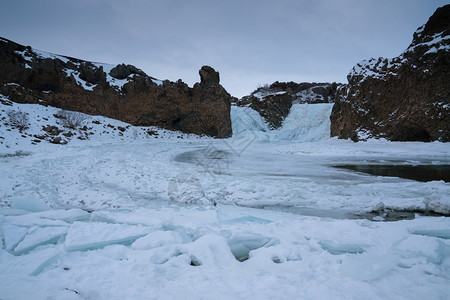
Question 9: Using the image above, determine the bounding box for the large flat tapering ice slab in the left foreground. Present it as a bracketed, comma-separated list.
[65, 222, 150, 251]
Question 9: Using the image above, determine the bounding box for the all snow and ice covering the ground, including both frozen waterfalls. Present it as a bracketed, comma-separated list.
[0, 99, 450, 299]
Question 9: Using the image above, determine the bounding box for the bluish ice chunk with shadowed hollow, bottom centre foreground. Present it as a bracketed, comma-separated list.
[228, 234, 278, 261]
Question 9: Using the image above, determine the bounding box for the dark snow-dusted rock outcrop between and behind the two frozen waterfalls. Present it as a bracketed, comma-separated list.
[234, 81, 340, 129]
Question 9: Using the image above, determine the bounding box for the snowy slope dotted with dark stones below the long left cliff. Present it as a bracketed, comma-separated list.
[0, 95, 200, 154]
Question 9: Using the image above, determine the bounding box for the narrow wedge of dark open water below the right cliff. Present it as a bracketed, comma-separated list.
[334, 164, 450, 182]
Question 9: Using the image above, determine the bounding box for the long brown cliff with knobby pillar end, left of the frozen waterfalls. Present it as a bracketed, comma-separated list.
[0, 38, 232, 138]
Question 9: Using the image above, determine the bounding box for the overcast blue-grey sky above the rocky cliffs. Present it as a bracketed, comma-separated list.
[0, 0, 450, 97]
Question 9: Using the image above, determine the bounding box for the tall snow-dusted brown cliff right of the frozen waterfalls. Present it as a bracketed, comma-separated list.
[331, 5, 450, 142]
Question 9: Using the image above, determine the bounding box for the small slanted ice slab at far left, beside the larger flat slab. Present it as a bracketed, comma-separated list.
[14, 227, 68, 255]
